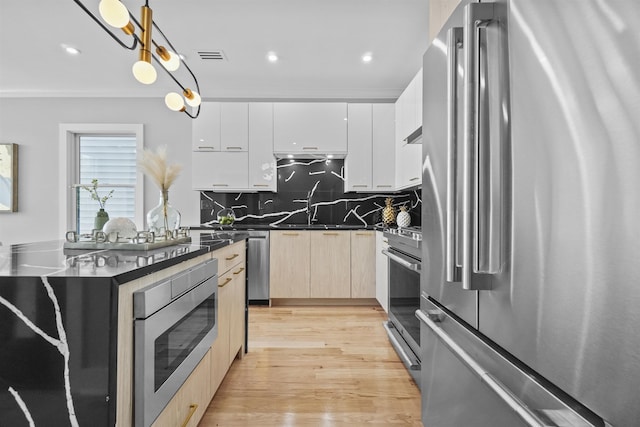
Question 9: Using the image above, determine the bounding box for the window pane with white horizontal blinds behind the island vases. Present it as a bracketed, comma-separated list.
[74, 134, 137, 233]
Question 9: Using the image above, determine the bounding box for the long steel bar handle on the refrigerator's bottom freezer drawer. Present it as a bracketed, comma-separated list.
[416, 310, 549, 427]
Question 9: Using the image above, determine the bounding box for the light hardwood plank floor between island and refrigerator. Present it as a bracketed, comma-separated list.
[200, 306, 422, 427]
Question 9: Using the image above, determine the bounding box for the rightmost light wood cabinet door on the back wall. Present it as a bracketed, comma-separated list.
[351, 230, 376, 298]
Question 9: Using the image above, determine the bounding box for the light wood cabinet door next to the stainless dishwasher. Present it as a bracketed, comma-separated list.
[269, 230, 311, 298]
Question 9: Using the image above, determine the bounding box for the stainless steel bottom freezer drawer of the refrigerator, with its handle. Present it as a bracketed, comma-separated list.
[416, 295, 603, 427]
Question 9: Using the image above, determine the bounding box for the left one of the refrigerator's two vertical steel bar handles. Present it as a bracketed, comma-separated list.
[446, 27, 462, 282]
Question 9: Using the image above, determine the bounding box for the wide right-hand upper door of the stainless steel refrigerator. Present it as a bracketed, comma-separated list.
[470, 0, 640, 426]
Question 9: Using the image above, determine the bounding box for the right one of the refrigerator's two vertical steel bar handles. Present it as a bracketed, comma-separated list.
[462, 3, 495, 290]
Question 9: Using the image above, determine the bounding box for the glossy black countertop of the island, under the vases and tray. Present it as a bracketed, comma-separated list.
[0, 236, 248, 284]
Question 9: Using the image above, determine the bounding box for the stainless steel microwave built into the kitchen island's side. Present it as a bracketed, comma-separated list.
[133, 259, 218, 427]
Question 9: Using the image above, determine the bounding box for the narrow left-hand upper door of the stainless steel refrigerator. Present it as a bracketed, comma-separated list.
[421, 0, 477, 326]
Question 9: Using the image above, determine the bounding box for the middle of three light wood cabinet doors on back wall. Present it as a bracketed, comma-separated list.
[309, 231, 351, 298]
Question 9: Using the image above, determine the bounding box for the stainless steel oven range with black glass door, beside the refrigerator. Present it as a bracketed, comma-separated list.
[383, 227, 422, 387]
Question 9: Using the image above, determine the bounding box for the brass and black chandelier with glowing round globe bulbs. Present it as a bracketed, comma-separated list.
[73, 0, 201, 119]
